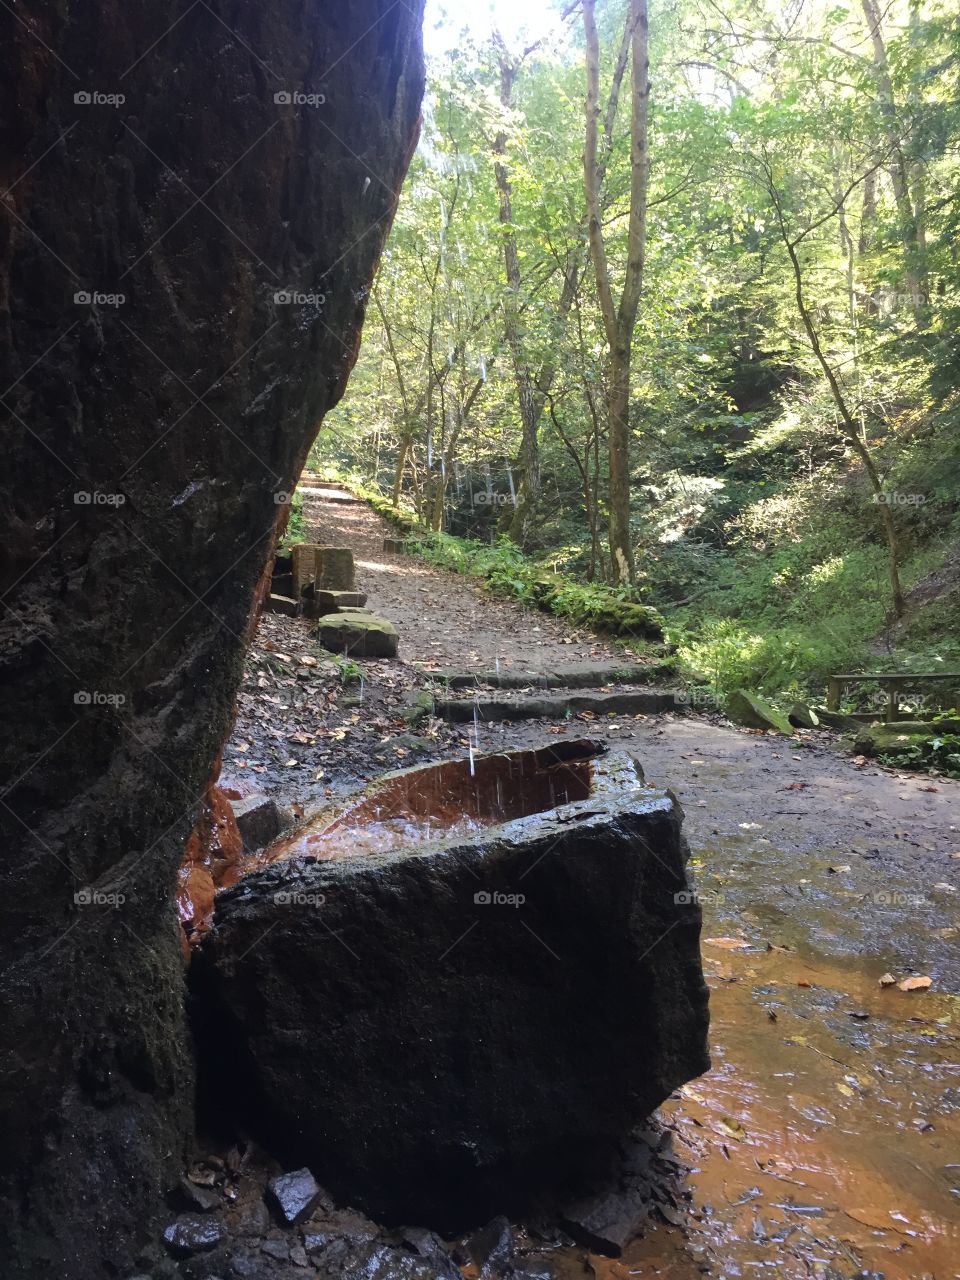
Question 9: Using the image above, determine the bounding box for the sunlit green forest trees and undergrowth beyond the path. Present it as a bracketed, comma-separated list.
[321, 0, 960, 690]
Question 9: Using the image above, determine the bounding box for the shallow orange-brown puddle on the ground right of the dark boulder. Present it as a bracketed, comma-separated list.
[545, 945, 960, 1280]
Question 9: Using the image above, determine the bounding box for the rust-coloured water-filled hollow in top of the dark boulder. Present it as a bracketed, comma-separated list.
[262, 741, 598, 863]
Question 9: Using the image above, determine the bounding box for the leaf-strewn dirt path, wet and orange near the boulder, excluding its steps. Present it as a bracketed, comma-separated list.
[225, 483, 960, 1280]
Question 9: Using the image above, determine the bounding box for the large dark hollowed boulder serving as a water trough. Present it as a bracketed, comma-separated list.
[195, 744, 709, 1229]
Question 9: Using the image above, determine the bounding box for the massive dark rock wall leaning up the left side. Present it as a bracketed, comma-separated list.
[0, 0, 422, 1280]
